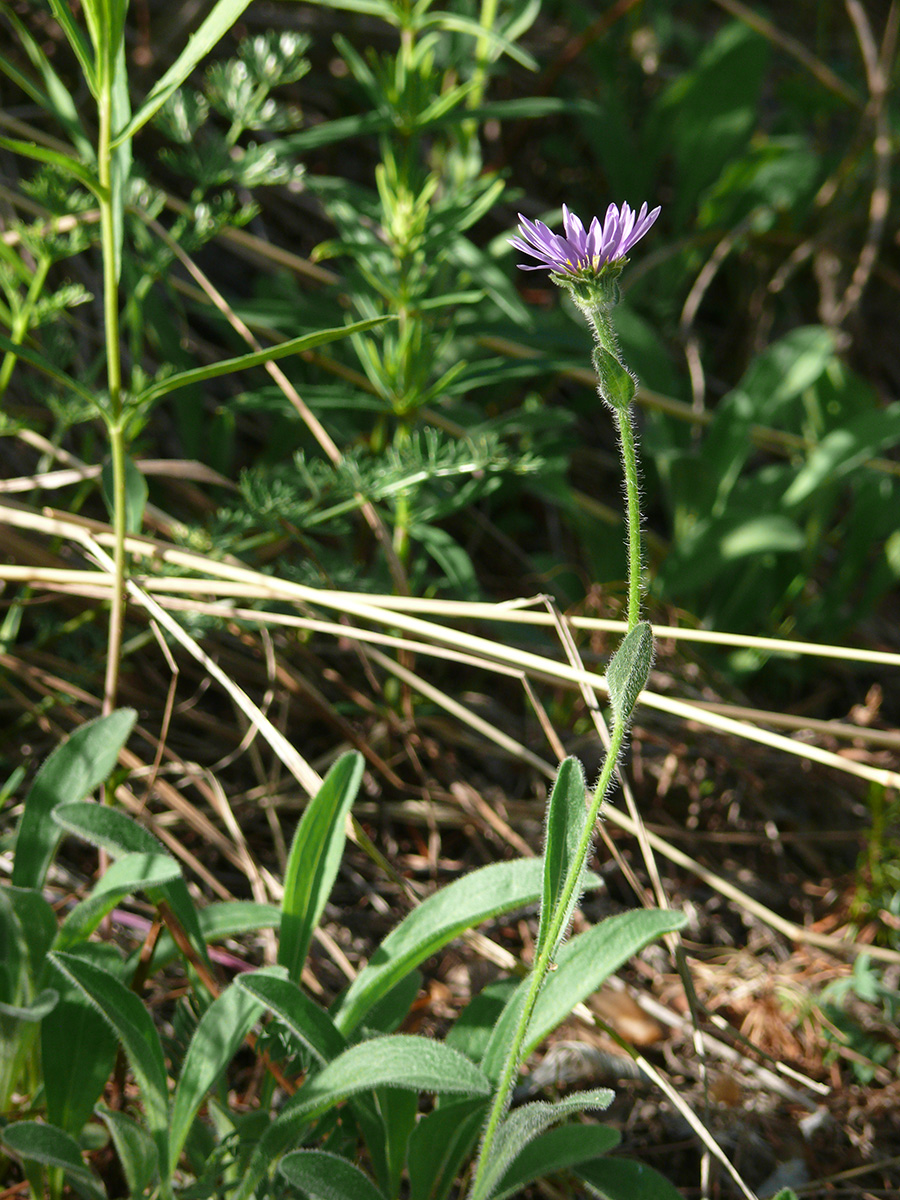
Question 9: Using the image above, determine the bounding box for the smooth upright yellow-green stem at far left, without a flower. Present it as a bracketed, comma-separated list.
[97, 71, 126, 715]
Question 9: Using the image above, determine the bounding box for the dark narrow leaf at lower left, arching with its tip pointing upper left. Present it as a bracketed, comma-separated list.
[47, 950, 169, 1182]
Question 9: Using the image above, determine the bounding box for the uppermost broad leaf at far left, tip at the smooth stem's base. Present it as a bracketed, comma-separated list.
[12, 708, 137, 888]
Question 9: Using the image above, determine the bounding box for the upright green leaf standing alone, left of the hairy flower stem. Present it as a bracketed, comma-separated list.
[278, 750, 364, 982]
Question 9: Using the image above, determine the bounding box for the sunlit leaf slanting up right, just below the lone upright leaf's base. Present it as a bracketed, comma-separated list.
[168, 967, 282, 1177]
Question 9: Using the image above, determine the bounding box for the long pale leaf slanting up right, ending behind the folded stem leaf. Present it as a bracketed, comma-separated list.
[335, 858, 542, 1034]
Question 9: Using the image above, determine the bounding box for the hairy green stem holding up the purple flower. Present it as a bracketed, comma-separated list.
[472, 277, 642, 1196]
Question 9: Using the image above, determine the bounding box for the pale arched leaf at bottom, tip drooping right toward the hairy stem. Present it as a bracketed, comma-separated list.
[234, 1033, 491, 1200]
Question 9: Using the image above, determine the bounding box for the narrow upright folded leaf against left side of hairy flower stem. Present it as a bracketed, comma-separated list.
[534, 758, 587, 959]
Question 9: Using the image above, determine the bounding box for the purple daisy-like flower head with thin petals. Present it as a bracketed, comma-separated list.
[510, 204, 660, 275]
